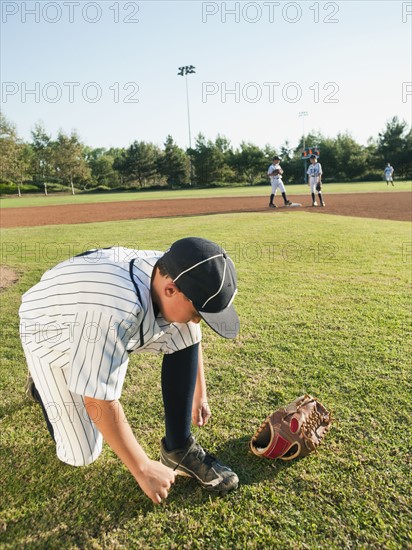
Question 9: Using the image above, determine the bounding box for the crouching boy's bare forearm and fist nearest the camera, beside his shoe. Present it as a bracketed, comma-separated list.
[84, 397, 175, 504]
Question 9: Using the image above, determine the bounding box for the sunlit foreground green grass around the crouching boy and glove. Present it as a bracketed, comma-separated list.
[0, 209, 412, 549]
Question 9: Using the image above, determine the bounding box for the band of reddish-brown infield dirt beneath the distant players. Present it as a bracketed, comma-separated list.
[0, 192, 412, 228]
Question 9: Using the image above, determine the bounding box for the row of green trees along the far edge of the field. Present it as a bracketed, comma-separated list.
[0, 114, 412, 195]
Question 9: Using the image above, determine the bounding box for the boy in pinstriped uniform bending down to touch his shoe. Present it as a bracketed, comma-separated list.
[19, 237, 239, 503]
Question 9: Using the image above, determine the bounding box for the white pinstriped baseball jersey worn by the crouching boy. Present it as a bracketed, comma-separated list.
[19, 247, 201, 400]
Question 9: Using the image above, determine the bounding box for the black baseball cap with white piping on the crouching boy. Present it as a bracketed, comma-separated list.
[162, 237, 240, 338]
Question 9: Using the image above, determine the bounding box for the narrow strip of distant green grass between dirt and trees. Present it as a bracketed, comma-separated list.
[0, 181, 412, 208]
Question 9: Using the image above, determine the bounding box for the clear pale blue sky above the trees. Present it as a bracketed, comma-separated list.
[1, 0, 412, 148]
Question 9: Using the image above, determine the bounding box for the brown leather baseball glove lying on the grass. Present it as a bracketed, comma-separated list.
[250, 394, 332, 460]
